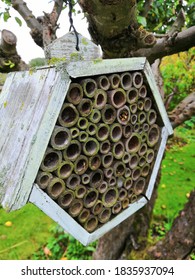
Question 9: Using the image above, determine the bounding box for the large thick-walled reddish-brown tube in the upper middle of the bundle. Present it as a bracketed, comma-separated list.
[108, 88, 127, 109]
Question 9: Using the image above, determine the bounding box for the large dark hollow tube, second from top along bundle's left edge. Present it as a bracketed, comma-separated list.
[58, 103, 79, 127]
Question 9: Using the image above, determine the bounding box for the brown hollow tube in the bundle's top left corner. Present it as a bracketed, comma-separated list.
[66, 83, 83, 105]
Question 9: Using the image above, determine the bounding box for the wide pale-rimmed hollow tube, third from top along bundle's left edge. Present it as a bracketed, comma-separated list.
[50, 126, 72, 150]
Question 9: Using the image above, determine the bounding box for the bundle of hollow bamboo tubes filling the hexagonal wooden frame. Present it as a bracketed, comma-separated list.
[36, 71, 161, 232]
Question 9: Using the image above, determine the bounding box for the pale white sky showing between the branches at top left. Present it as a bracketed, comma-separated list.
[0, 0, 90, 63]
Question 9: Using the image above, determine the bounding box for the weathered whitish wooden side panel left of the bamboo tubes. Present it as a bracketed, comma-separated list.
[0, 68, 70, 210]
